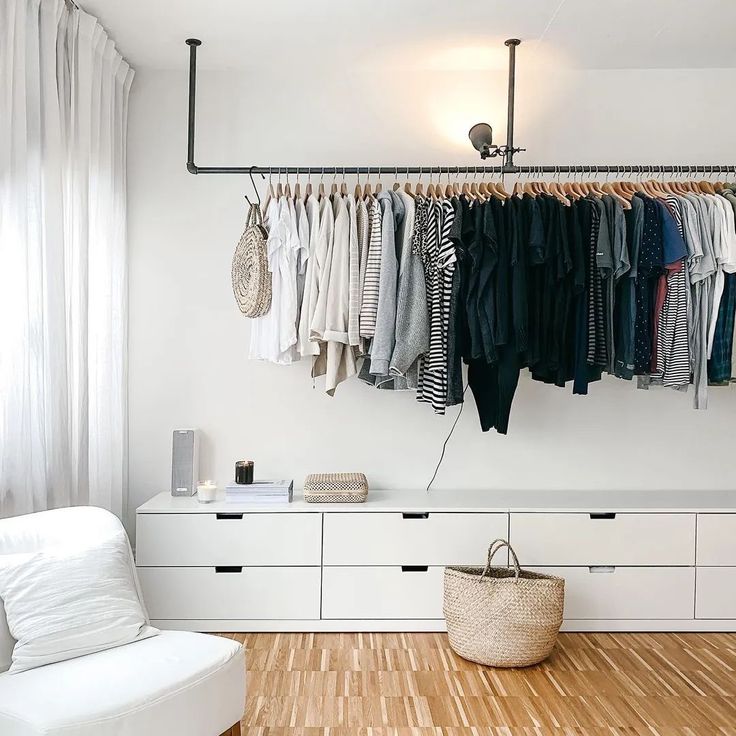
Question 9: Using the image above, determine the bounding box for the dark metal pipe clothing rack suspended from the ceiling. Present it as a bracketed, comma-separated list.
[186, 38, 736, 177]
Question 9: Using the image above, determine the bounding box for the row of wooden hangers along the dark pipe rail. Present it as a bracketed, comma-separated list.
[256, 170, 728, 209]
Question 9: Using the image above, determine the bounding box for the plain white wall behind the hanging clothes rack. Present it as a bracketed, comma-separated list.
[129, 62, 736, 524]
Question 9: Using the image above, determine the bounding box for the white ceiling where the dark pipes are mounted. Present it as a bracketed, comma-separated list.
[79, 0, 736, 71]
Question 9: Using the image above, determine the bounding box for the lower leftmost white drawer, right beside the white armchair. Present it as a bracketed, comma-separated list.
[138, 567, 320, 619]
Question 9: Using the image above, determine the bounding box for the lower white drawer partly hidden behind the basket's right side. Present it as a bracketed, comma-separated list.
[535, 567, 695, 619]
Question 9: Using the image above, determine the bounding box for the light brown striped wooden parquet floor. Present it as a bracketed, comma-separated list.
[216, 634, 736, 736]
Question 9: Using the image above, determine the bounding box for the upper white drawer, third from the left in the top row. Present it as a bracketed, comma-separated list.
[510, 513, 695, 566]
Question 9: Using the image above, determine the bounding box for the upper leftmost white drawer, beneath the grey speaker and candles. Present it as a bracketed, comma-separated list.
[136, 513, 322, 567]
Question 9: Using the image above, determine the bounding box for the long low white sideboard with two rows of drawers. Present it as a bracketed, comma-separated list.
[136, 491, 736, 631]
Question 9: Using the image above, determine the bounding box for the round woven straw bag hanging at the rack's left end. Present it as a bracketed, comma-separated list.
[232, 204, 271, 317]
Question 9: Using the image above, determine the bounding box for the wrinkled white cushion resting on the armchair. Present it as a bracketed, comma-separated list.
[0, 528, 158, 673]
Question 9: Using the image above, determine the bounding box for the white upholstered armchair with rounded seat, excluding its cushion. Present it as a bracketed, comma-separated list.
[0, 507, 245, 736]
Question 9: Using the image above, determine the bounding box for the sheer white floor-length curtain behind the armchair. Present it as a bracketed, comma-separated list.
[0, 0, 133, 516]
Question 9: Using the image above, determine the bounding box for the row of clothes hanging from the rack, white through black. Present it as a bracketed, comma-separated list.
[250, 175, 736, 434]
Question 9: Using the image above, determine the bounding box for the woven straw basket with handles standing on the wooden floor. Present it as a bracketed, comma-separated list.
[444, 539, 565, 667]
